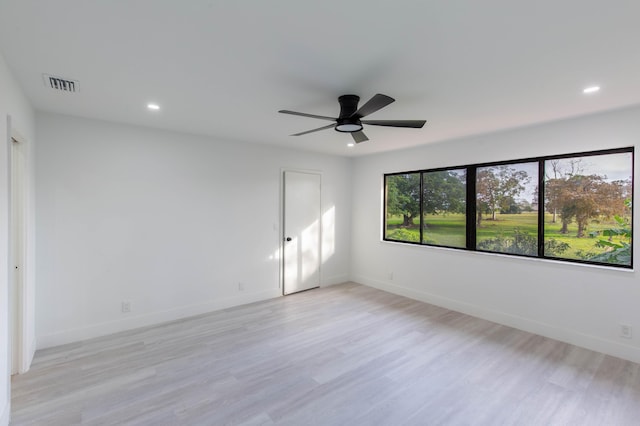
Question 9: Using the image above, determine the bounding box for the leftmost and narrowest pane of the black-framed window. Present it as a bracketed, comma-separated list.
[384, 173, 420, 243]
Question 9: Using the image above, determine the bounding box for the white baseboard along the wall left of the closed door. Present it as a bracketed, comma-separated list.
[37, 289, 282, 349]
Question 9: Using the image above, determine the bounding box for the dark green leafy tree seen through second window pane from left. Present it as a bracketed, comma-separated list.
[422, 170, 467, 214]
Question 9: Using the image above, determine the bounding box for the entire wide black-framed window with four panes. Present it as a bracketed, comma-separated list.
[384, 148, 633, 268]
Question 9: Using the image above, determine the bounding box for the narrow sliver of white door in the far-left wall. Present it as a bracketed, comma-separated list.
[9, 139, 25, 374]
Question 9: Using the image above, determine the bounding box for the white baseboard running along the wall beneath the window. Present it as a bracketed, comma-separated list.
[352, 276, 640, 363]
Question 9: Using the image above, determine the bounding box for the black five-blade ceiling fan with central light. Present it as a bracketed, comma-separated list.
[278, 93, 426, 143]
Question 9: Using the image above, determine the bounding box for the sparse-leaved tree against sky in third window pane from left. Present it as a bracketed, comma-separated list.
[476, 166, 531, 226]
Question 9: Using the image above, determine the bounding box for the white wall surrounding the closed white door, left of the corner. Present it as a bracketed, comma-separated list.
[36, 113, 351, 348]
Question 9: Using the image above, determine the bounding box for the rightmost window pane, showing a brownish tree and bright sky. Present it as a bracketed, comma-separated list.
[544, 152, 633, 266]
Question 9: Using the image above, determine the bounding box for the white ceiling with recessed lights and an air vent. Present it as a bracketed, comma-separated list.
[0, 0, 640, 156]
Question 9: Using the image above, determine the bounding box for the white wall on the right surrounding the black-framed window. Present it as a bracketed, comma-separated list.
[351, 107, 640, 362]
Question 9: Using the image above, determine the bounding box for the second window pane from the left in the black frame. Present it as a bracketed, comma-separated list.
[422, 169, 467, 247]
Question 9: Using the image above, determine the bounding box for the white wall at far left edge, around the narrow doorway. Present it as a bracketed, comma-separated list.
[0, 51, 35, 424]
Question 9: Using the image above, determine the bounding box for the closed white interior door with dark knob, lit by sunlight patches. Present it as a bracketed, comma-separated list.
[282, 171, 322, 294]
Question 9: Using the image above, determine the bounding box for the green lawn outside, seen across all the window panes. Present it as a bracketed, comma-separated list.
[386, 212, 632, 260]
